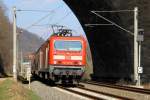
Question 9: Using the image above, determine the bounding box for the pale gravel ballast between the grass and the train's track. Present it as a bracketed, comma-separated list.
[26, 81, 89, 100]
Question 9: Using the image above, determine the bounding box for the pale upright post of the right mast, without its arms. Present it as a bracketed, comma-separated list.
[134, 7, 139, 85]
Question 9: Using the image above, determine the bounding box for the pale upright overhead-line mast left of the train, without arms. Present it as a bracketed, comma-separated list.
[13, 7, 17, 81]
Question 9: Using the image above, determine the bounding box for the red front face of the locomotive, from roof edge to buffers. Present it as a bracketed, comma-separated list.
[49, 36, 86, 82]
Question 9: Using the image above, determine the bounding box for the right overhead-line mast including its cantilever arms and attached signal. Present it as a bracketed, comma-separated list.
[90, 7, 144, 86]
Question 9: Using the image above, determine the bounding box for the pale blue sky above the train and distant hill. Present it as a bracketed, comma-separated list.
[3, 0, 85, 39]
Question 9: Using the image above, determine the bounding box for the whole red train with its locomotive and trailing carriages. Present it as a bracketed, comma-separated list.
[31, 29, 87, 84]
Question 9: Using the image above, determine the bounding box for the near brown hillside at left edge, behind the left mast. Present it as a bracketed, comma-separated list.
[0, 1, 13, 74]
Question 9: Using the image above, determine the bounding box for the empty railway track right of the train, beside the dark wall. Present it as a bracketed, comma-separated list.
[83, 81, 150, 95]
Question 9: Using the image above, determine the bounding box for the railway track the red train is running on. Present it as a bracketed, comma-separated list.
[58, 86, 131, 100]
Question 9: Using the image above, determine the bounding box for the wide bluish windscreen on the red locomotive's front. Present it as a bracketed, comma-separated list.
[54, 40, 82, 51]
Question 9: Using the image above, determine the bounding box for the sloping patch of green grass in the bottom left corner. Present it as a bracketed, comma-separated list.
[0, 79, 40, 100]
